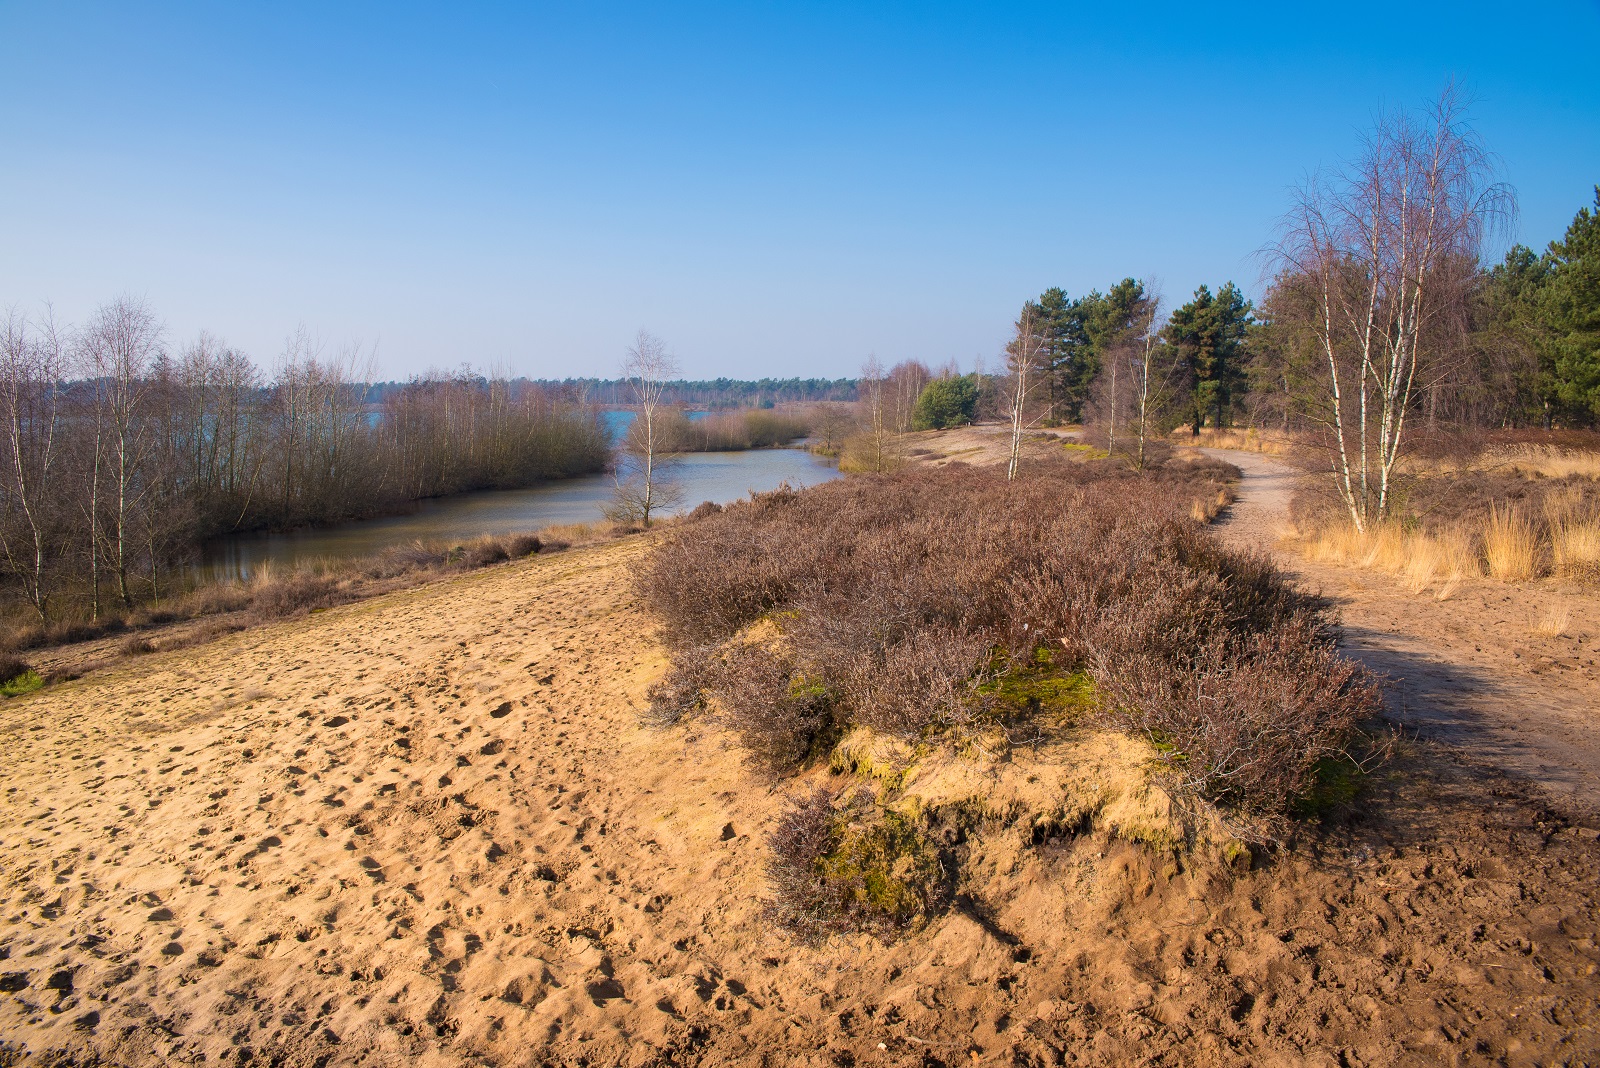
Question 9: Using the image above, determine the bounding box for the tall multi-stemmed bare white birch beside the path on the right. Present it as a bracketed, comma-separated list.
[1274, 86, 1515, 531]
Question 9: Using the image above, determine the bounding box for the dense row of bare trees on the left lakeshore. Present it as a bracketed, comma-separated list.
[0, 299, 611, 622]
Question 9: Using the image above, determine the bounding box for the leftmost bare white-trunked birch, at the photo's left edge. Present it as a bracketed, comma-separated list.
[0, 309, 67, 624]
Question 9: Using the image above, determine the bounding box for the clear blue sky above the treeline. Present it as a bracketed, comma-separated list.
[0, 0, 1600, 377]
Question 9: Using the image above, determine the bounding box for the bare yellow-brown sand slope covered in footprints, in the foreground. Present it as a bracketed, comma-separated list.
[0, 539, 1600, 1066]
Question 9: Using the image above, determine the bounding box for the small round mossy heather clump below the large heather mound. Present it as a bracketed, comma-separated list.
[766, 788, 947, 942]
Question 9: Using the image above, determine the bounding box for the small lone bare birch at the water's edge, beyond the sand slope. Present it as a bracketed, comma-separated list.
[605, 329, 683, 526]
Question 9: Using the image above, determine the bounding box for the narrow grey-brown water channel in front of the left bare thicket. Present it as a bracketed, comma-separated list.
[198, 449, 838, 580]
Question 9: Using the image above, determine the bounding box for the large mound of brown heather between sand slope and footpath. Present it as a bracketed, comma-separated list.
[637, 460, 1376, 819]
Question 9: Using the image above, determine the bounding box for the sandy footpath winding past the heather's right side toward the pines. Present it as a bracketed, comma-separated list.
[1205, 449, 1600, 812]
